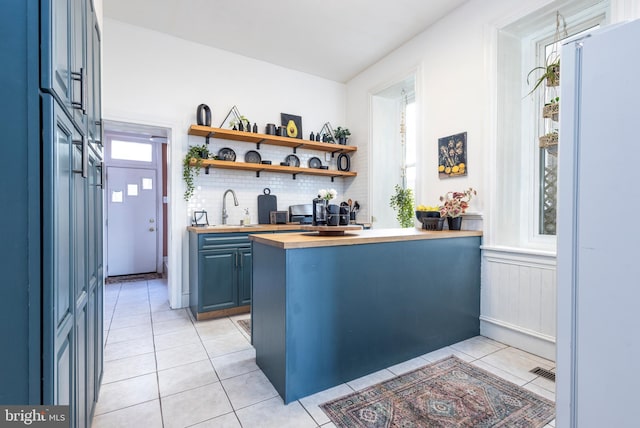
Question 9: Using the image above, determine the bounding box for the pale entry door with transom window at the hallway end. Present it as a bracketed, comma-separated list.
[104, 121, 170, 277]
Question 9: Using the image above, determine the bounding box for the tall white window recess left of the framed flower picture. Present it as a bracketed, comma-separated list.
[369, 73, 417, 228]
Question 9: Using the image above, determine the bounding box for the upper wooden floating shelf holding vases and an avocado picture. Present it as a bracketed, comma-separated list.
[189, 125, 358, 155]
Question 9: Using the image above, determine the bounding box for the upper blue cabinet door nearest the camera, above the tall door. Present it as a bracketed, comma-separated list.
[41, 0, 89, 130]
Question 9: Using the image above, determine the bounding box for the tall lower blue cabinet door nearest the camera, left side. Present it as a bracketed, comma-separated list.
[42, 95, 77, 404]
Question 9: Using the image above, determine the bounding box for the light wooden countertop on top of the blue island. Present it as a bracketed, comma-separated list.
[249, 228, 482, 249]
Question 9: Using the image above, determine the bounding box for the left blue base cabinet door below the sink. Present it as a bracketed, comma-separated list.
[198, 249, 238, 312]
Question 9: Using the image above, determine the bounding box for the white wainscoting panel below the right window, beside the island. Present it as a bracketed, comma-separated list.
[480, 247, 556, 361]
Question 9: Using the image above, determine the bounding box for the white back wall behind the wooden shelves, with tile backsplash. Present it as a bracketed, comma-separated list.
[103, 19, 348, 307]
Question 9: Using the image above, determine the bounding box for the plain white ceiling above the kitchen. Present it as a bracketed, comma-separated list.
[103, 0, 467, 82]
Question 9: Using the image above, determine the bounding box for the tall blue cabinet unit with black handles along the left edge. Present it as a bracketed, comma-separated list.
[0, 0, 104, 427]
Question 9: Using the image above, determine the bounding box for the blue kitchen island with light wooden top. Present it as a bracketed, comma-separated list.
[250, 229, 481, 403]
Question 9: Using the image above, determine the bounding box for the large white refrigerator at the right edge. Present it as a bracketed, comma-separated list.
[556, 21, 640, 428]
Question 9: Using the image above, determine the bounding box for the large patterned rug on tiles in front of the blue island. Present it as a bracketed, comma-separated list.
[320, 356, 555, 428]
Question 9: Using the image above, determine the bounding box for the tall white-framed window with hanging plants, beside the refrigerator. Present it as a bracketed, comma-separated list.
[489, 0, 609, 247]
